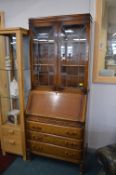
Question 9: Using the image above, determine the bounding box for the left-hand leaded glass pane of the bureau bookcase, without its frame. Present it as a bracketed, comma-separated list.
[33, 27, 55, 86]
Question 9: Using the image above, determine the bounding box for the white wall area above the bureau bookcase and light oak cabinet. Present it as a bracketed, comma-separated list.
[0, 0, 89, 28]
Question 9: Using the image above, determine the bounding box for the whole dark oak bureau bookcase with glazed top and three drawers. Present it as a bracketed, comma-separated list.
[26, 14, 90, 173]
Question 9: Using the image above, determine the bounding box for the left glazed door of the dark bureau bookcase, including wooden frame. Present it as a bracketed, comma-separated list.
[30, 23, 57, 89]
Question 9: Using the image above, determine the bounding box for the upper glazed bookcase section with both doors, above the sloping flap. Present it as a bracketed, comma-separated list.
[29, 15, 90, 91]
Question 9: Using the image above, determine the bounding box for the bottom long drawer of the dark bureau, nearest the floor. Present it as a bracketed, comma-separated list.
[28, 141, 82, 163]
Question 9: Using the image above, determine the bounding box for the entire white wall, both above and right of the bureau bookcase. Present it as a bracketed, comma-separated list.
[0, 0, 116, 148]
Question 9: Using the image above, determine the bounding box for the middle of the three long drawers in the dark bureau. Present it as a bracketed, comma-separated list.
[27, 131, 83, 149]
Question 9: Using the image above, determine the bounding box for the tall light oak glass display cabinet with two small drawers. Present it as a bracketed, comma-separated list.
[0, 28, 30, 159]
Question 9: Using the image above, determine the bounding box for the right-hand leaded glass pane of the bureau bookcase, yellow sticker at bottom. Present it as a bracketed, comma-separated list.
[59, 25, 88, 87]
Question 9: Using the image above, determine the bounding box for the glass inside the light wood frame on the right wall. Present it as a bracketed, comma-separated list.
[99, 0, 116, 76]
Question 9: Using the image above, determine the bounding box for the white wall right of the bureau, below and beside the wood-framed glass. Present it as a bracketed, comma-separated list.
[88, 0, 116, 148]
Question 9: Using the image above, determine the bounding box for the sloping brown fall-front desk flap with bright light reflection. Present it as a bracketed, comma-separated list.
[26, 91, 86, 122]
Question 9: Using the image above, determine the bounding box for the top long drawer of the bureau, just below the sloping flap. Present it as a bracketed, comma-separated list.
[27, 121, 84, 139]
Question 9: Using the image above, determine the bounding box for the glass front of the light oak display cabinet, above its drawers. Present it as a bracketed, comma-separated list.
[0, 34, 20, 124]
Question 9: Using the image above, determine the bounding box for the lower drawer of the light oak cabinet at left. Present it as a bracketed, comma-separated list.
[3, 137, 22, 155]
